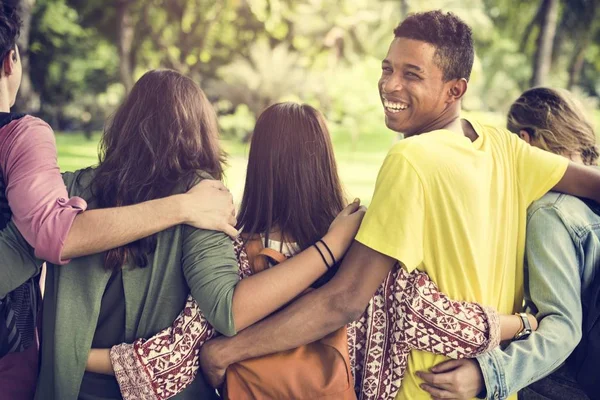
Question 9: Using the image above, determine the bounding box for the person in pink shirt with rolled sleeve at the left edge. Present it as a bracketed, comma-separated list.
[0, 2, 237, 400]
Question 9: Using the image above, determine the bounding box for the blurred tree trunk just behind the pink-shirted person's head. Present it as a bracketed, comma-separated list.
[15, 0, 40, 113]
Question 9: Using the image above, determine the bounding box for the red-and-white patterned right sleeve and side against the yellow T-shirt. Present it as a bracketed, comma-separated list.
[348, 266, 500, 400]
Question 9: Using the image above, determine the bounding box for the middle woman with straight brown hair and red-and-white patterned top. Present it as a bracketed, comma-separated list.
[88, 103, 535, 399]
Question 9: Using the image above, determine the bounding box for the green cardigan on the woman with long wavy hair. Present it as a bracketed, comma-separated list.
[36, 169, 239, 400]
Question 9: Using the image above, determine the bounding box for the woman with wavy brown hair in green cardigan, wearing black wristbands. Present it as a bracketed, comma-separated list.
[36, 70, 363, 399]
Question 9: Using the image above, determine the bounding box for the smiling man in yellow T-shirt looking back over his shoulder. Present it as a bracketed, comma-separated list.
[201, 11, 600, 400]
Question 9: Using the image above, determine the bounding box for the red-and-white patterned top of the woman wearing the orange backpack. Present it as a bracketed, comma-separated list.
[110, 239, 500, 400]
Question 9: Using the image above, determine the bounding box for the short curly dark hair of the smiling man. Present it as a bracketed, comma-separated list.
[394, 10, 474, 82]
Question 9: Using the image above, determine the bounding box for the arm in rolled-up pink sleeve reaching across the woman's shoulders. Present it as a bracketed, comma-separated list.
[0, 117, 236, 264]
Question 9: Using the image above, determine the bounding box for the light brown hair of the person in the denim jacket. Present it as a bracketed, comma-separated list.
[507, 87, 598, 165]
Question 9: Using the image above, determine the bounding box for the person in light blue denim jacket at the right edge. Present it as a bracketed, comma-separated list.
[424, 87, 600, 400]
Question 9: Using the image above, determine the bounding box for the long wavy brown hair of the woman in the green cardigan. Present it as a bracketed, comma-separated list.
[92, 70, 224, 269]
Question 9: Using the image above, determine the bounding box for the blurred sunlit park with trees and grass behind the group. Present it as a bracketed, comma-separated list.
[15, 0, 600, 203]
